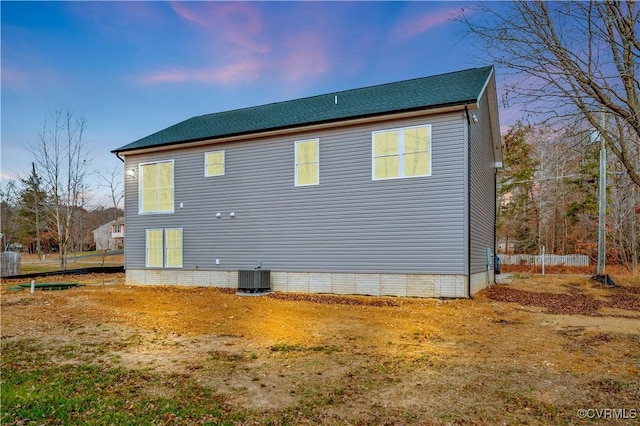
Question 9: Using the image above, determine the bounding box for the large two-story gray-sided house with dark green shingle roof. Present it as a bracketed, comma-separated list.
[112, 67, 502, 297]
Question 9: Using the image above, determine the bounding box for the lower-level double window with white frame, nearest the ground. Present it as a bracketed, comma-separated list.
[145, 228, 182, 268]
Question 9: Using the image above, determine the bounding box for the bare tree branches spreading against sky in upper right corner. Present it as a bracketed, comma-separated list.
[461, 0, 640, 186]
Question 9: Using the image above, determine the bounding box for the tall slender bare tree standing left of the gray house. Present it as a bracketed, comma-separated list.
[29, 110, 90, 270]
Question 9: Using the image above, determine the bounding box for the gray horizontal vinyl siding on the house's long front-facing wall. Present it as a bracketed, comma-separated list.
[125, 113, 466, 274]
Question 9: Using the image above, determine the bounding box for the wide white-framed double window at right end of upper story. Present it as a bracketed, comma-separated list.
[371, 124, 431, 180]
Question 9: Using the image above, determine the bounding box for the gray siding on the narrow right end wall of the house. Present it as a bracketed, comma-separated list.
[469, 92, 496, 274]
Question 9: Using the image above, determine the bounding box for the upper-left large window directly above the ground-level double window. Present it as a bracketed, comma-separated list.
[138, 160, 174, 213]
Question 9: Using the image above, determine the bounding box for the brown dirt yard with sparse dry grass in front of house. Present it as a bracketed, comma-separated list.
[1, 274, 640, 425]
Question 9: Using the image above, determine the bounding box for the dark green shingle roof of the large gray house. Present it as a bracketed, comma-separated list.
[112, 67, 493, 153]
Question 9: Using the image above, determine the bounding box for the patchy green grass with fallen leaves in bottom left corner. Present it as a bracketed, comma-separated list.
[0, 341, 246, 425]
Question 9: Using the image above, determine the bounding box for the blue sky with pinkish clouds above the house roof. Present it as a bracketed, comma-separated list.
[0, 1, 504, 206]
